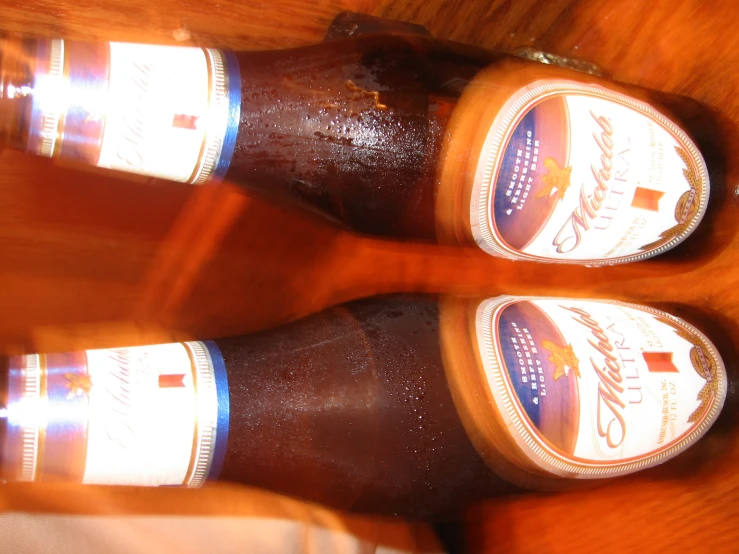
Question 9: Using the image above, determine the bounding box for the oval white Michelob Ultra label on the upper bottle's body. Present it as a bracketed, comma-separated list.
[470, 80, 709, 264]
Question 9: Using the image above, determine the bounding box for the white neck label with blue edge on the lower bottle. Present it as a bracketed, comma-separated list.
[3, 342, 228, 487]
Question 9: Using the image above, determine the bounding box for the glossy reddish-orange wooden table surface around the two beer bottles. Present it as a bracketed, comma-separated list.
[0, 0, 739, 552]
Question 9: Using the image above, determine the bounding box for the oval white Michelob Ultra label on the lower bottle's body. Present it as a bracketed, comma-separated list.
[477, 298, 726, 478]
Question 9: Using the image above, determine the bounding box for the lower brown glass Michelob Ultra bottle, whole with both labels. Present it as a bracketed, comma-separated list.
[0, 296, 727, 518]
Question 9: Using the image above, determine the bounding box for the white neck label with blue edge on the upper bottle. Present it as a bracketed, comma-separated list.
[28, 39, 241, 184]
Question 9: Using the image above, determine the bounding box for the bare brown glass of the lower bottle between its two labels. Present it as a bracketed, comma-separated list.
[219, 297, 513, 517]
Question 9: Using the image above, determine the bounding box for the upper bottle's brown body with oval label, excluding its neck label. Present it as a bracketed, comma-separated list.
[229, 35, 709, 265]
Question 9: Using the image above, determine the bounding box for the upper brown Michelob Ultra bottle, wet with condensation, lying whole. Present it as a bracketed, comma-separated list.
[0, 14, 718, 265]
